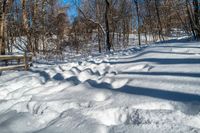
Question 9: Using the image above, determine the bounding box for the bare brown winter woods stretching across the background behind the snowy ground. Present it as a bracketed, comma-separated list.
[0, 0, 200, 58]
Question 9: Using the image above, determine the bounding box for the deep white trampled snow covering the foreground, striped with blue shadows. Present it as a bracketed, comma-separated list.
[0, 42, 200, 133]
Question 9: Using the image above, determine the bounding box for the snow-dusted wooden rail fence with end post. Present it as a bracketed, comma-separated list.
[0, 53, 32, 71]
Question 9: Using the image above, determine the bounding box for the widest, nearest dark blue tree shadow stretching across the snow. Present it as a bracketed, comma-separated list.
[87, 80, 200, 102]
